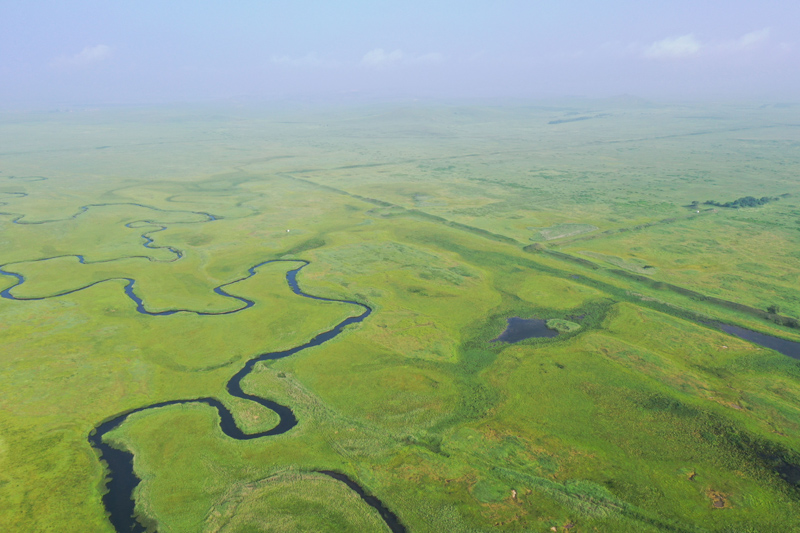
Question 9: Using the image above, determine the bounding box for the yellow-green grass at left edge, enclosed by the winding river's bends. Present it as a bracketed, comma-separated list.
[0, 263, 358, 529]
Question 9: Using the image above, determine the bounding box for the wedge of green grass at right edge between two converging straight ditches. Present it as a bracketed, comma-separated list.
[565, 212, 800, 317]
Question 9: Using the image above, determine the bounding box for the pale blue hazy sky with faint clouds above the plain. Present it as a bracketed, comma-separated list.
[0, 0, 800, 106]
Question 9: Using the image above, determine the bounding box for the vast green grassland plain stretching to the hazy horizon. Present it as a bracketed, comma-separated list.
[0, 101, 800, 533]
